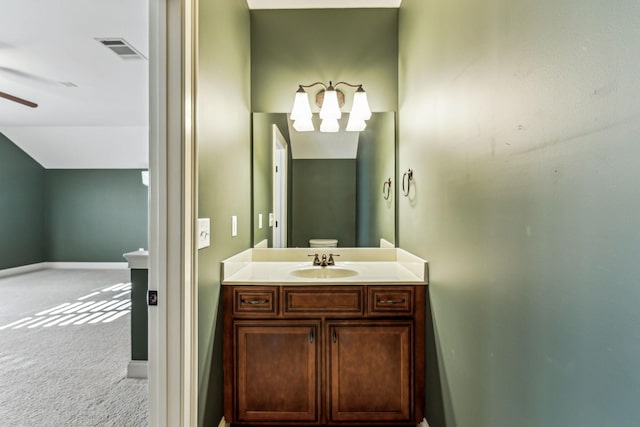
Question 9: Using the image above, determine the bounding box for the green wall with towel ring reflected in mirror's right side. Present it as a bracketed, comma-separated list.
[356, 113, 397, 247]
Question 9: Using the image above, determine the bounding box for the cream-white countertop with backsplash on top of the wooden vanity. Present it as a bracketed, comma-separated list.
[221, 248, 428, 285]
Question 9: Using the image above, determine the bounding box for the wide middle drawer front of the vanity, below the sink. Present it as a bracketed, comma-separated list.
[283, 286, 363, 315]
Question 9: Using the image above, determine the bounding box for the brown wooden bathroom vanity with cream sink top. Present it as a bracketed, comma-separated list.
[222, 248, 428, 426]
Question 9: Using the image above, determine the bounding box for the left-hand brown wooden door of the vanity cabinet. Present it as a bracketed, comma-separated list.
[235, 321, 320, 422]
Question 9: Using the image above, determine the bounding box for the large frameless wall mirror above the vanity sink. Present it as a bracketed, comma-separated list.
[253, 112, 397, 247]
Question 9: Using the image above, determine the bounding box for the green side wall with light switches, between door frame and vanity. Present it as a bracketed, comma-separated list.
[196, 0, 251, 426]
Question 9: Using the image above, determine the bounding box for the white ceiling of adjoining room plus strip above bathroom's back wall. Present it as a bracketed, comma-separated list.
[0, 0, 401, 169]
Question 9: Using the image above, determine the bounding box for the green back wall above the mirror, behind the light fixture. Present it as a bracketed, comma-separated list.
[251, 9, 398, 113]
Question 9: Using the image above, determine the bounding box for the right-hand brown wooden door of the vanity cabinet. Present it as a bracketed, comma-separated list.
[327, 321, 413, 422]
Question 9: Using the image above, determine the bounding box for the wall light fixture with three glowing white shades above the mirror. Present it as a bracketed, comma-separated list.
[291, 82, 371, 132]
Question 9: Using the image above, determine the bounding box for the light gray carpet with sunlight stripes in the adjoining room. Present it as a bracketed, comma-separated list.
[0, 270, 148, 427]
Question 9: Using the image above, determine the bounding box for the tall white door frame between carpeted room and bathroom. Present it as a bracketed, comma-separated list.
[148, 0, 198, 427]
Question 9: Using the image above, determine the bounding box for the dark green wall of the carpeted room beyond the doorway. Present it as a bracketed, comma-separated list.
[0, 134, 148, 269]
